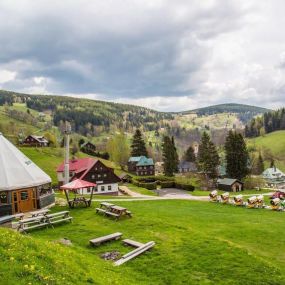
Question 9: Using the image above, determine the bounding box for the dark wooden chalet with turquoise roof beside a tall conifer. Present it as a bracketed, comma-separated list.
[128, 156, 155, 176]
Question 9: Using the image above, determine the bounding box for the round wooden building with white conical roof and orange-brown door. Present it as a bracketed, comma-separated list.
[0, 133, 55, 216]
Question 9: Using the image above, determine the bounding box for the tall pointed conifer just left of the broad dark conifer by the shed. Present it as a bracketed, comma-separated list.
[198, 132, 220, 178]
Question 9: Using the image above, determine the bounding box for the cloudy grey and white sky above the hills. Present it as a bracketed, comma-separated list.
[0, 0, 285, 111]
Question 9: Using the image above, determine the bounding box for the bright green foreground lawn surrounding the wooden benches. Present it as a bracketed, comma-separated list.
[0, 200, 285, 285]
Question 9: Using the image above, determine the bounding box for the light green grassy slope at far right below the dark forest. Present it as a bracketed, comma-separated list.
[248, 131, 285, 172]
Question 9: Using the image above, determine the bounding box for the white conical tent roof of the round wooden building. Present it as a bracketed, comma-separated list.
[0, 133, 51, 191]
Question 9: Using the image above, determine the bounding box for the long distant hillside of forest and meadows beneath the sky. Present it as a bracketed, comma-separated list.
[0, 91, 266, 159]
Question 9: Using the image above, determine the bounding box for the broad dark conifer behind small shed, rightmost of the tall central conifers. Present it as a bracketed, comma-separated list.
[225, 131, 249, 179]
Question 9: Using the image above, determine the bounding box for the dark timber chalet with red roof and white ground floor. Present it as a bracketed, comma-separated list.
[57, 157, 121, 195]
